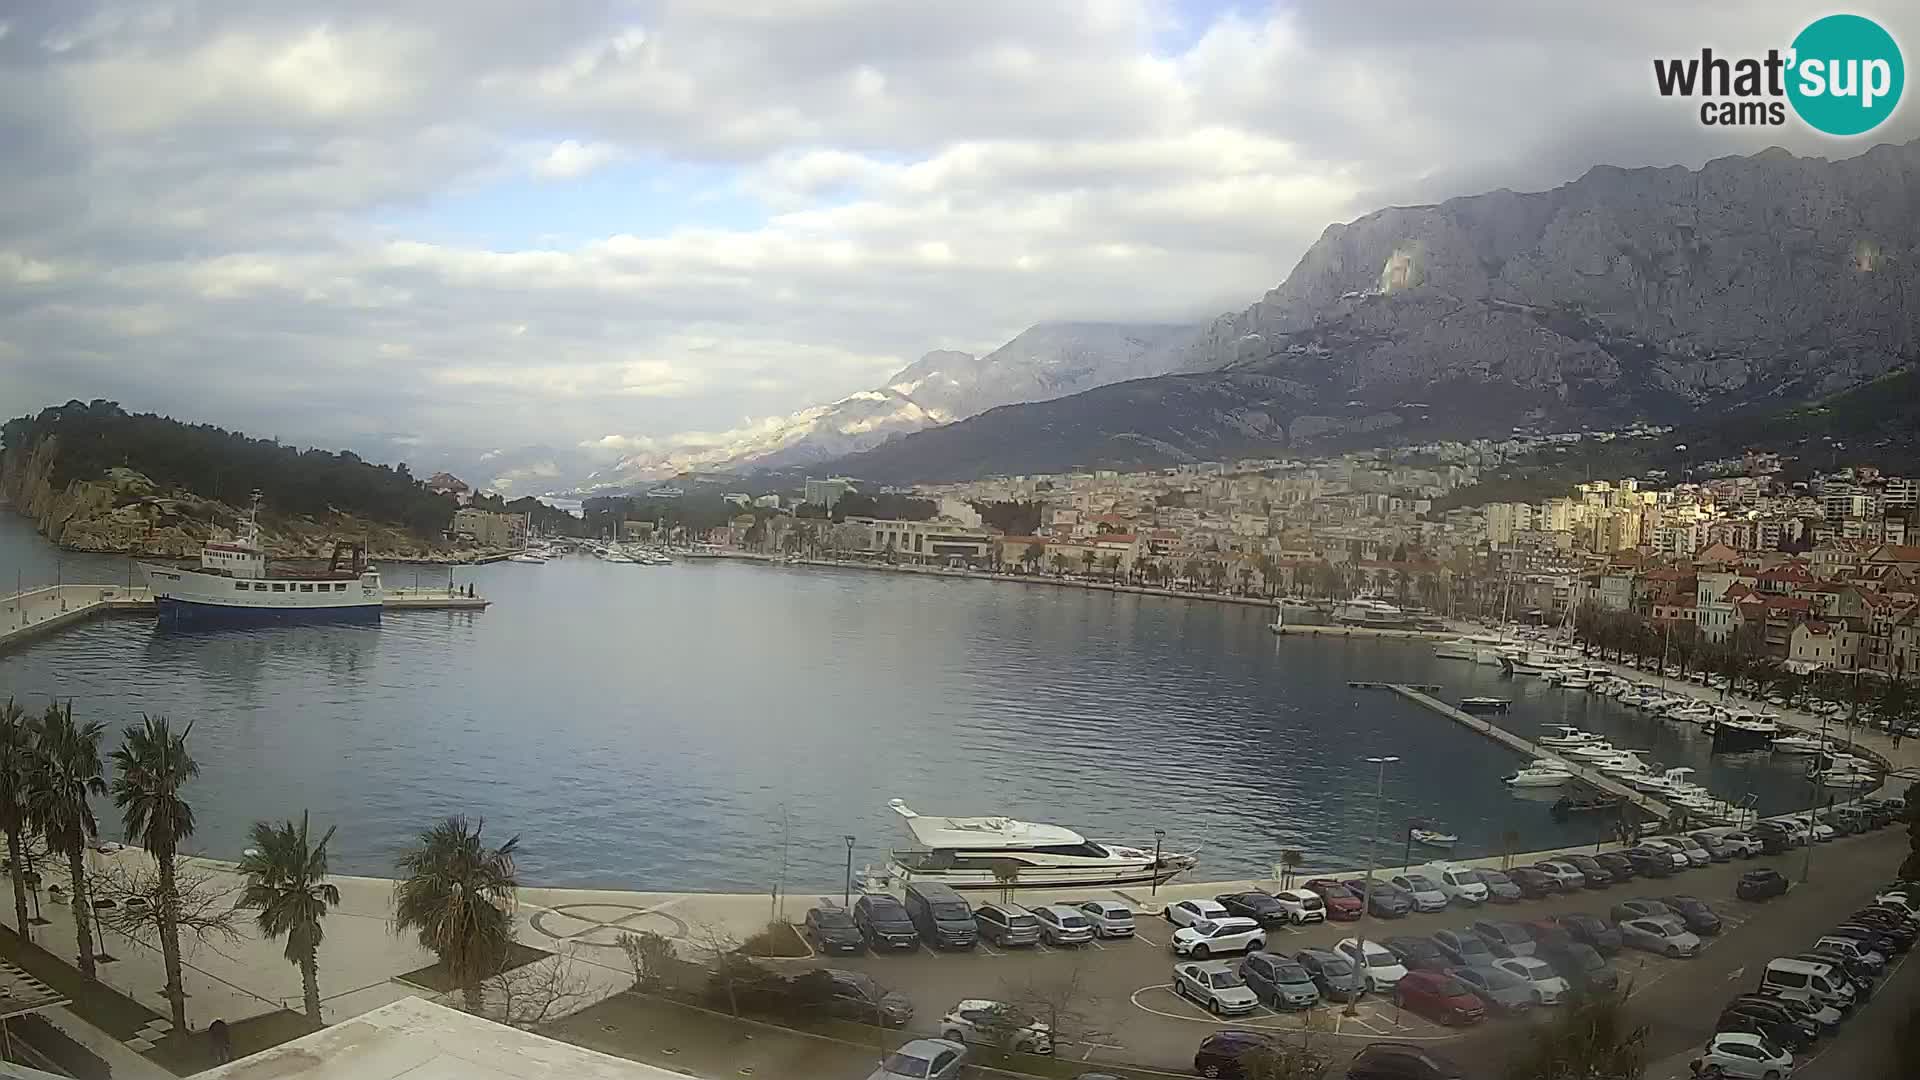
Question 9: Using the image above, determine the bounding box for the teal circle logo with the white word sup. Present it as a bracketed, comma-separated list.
[1788, 15, 1907, 135]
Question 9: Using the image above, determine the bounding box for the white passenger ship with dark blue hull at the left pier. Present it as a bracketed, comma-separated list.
[142, 496, 382, 626]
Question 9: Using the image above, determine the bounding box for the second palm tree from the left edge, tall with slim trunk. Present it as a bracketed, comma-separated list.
[27, 701, 108, 978]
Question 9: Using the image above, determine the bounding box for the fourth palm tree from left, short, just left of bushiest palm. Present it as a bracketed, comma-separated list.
[234, 811, 340, 1024]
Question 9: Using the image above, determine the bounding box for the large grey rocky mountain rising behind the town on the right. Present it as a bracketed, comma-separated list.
[835, 142, 1920, 482]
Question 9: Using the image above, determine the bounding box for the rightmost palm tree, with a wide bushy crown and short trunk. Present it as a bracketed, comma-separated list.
[394, 815, 520, 1015]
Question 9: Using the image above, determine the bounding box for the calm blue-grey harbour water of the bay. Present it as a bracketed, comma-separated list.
[0, 511, 1807, 892]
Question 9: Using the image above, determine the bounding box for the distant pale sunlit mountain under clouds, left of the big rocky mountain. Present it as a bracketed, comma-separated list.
[582, 323, 1198, 490]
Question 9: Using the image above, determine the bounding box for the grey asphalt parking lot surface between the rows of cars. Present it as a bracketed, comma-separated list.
[779, 828, 1907, 1072]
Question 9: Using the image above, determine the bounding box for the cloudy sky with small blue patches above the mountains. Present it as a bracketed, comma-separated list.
[0, 0, 1920, 490]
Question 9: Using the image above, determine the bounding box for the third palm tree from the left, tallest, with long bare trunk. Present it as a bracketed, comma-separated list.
[113, 717, 200, 1032]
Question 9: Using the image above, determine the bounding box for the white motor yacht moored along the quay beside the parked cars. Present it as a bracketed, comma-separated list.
[887, 799, 1198, 888]
